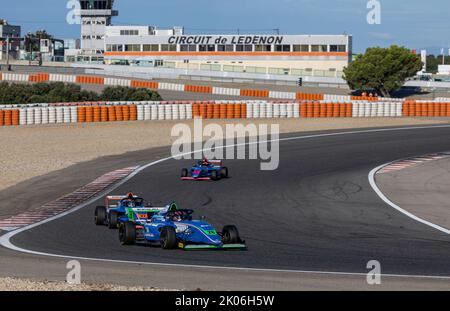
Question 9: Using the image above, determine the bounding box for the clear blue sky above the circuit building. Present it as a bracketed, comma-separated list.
[0, 0, 450, 53]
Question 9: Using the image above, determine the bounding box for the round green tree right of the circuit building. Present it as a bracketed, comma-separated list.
[344, 45, 423, 97]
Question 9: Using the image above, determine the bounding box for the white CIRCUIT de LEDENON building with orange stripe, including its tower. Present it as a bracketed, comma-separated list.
[76, 1, 352, 77]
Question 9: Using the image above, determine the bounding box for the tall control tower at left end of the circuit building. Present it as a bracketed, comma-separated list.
[79, 0, 119, 56]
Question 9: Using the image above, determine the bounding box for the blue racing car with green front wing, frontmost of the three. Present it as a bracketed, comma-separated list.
[119, 203, 247, 250]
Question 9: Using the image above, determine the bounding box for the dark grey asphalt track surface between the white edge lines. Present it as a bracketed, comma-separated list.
[7, 127, 450, 277]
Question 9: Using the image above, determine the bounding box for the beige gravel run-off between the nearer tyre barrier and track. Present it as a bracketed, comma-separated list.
[0, 118, 450, 190]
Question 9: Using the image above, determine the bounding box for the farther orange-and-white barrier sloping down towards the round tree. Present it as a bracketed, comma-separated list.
[0, 73, 386, 102]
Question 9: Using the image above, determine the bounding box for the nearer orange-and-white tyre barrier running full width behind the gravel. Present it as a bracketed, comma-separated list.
[0, 100, 444, 126]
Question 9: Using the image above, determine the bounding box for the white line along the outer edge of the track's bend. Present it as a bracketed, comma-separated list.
[0, 125, 450, 280]
